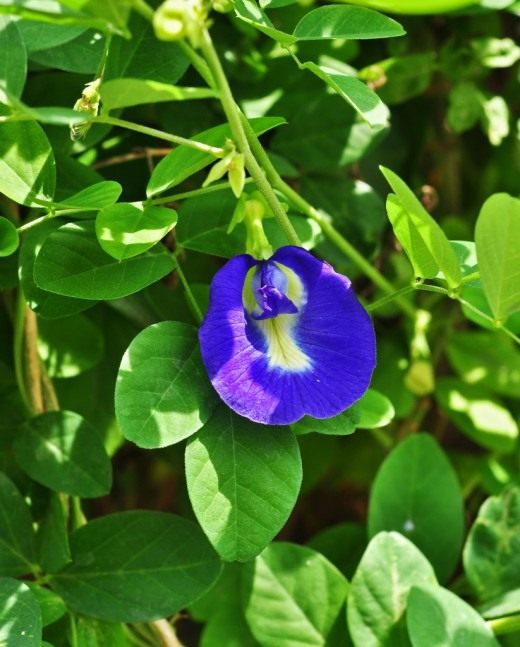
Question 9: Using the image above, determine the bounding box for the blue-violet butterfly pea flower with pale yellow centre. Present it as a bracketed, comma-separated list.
[199, 247, 376, 425]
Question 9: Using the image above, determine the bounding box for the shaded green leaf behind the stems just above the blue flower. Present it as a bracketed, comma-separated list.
[175, 191, 320, 258]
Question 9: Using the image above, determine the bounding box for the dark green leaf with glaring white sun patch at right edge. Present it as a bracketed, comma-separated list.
[435, 378, 518, 452]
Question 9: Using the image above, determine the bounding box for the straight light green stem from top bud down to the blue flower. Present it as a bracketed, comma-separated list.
[201, 30, 301, 247]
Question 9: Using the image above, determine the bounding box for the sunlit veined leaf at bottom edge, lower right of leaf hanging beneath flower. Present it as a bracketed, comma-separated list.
[243, 543, 348, 647]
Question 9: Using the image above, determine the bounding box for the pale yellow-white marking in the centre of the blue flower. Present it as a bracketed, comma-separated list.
[255, 314, 311, 372]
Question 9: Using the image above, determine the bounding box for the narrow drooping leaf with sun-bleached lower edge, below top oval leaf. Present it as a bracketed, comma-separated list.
[301, 62, 390, 128]
